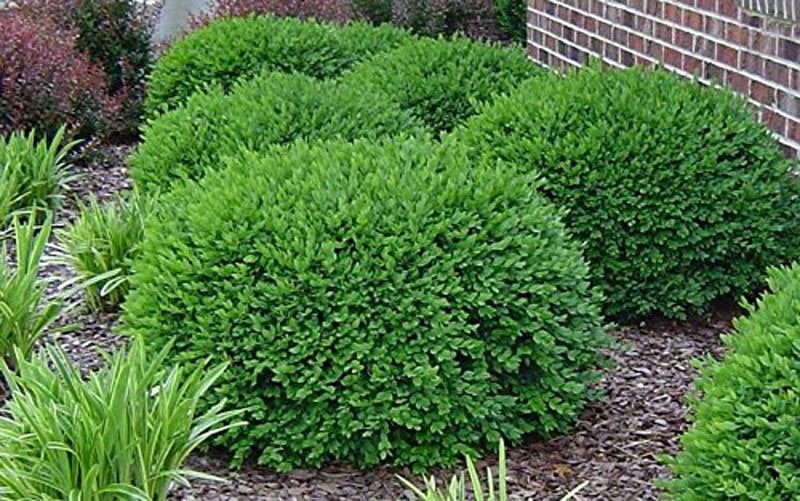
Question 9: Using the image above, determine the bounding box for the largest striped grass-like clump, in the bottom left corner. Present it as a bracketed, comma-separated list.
[0, 334, 247, 501]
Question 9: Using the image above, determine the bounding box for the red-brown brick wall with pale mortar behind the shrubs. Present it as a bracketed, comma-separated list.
[528, 0, 800, 157]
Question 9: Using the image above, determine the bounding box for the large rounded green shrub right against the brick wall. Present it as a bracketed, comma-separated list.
[454, 68, 800, 318]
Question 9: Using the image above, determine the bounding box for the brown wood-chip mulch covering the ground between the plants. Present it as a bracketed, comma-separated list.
[17, 142, 735, 500]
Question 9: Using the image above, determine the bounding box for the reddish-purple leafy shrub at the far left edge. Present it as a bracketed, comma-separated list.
[0, 9, 119, 135]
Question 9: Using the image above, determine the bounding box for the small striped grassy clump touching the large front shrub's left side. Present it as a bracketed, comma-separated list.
[58, 192, 155, 311]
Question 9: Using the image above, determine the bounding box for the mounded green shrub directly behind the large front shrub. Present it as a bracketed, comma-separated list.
[129, 73, 423, 191]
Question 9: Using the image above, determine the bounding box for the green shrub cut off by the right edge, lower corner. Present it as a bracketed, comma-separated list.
[668, 264, 800, 500]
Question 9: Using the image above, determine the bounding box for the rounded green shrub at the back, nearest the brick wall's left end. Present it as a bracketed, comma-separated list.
[343, 37, 542, 132]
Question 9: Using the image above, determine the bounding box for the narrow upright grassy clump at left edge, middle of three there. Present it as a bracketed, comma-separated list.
[0, 214, 62, 368]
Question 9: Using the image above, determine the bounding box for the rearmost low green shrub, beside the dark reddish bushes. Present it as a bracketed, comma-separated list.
[146, 17, 412, 116]
